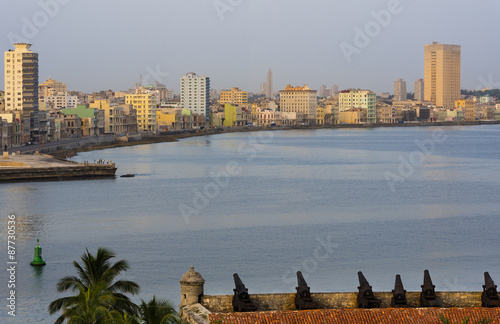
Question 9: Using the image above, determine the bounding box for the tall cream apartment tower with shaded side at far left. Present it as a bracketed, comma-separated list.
[4, 43, 38, 138]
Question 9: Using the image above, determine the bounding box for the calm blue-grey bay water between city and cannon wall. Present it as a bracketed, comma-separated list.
[0, 125, 500, 323]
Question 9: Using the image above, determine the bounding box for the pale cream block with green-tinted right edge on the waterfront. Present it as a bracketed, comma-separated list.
[339, 89, 377, 124]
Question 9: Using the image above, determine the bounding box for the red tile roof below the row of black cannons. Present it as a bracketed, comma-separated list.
[209, 307, 500, 324]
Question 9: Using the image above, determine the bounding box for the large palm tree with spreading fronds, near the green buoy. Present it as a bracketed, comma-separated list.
[48, 247, 139, 324]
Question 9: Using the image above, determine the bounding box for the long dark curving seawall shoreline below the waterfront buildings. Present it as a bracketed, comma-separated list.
[49, 120, 500, 159]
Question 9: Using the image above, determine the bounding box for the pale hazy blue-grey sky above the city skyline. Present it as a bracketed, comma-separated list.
[0, 0, 500, 93]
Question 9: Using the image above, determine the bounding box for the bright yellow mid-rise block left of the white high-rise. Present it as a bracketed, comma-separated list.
[125, 91, 157, 132]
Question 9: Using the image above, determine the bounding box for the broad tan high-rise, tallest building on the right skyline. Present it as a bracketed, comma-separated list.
[424, 42, 461, 108]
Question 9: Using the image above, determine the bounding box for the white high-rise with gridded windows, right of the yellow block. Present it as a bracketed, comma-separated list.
[180, 72, 210, 120]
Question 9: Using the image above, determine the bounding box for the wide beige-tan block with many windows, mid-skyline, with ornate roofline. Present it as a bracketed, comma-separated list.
[280, 85, 318, 124]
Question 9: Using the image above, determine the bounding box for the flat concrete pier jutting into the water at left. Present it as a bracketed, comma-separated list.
[0, 153, 116, 182]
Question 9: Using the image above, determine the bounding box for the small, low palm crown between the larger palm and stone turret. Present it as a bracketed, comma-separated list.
[139, 296, 179, 324]
